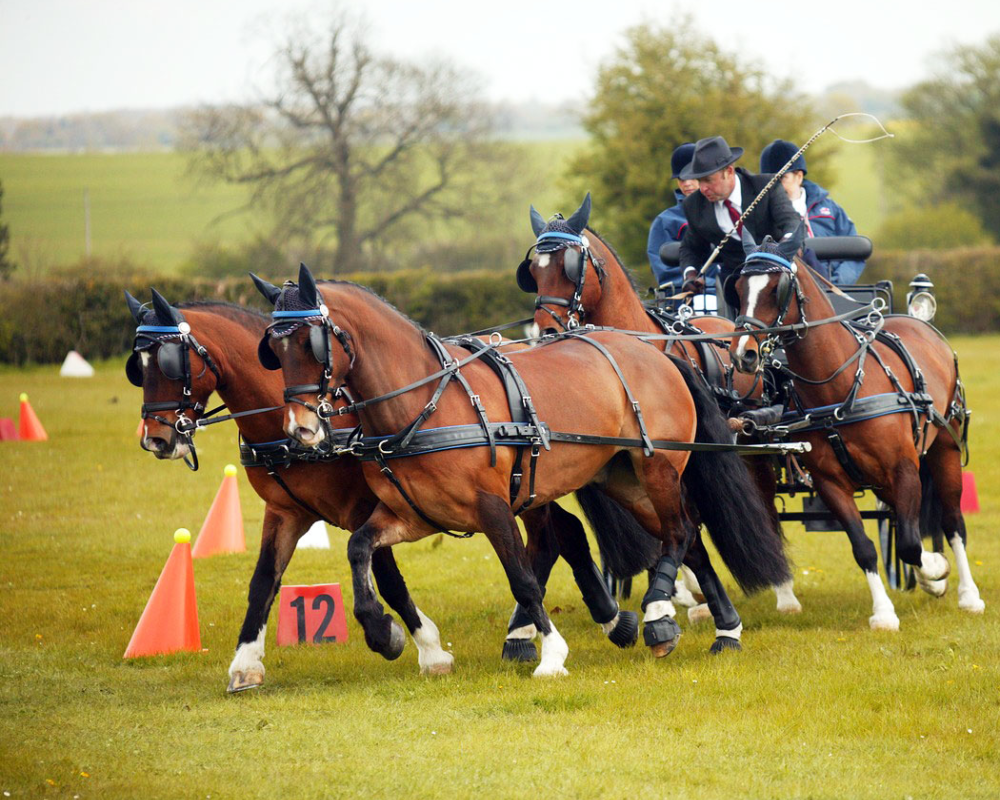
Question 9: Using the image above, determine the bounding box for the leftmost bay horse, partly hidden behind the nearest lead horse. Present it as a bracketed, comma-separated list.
[126, 289, 638, 692]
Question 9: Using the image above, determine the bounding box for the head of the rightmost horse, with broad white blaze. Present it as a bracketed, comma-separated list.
[725, 225, 805, 372]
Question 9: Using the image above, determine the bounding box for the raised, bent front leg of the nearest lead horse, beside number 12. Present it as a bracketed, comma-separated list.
[347, 504, 406, 661]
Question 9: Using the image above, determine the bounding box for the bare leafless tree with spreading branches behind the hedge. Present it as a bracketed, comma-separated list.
[184, 10, 516, 272]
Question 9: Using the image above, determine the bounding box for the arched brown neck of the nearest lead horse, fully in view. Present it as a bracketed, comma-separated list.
[319, 284, 441, 434]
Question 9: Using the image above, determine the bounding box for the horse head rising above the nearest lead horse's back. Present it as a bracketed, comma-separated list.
[517, 192, 604, 331]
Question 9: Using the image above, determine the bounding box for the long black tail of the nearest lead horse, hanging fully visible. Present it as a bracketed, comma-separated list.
[669, 356, 791, 594]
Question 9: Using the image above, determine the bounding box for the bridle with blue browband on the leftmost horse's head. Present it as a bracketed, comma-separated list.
[125, 321, 225, 471]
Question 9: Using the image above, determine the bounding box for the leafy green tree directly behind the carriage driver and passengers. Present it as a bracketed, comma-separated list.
[567, 19, 830, 273]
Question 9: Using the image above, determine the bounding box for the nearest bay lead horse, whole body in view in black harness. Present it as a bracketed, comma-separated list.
[252, 265, 788, 676]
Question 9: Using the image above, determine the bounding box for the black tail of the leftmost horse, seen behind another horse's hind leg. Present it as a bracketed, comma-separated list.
[576, 486, 663, 580]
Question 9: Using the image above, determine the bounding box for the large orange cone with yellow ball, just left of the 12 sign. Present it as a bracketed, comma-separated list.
[124, 528, 201, 658]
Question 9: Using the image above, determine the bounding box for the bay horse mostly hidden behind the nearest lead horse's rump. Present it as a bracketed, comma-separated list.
[517, 193, 802, 621]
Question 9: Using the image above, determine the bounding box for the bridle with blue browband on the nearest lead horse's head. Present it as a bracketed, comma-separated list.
[257, 303, 356, 424]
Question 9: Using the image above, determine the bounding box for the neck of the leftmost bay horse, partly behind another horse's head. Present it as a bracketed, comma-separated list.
[184, 310, 285, 442]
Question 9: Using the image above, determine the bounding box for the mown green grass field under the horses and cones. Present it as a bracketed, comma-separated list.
[0, 336, 1000, 800]
